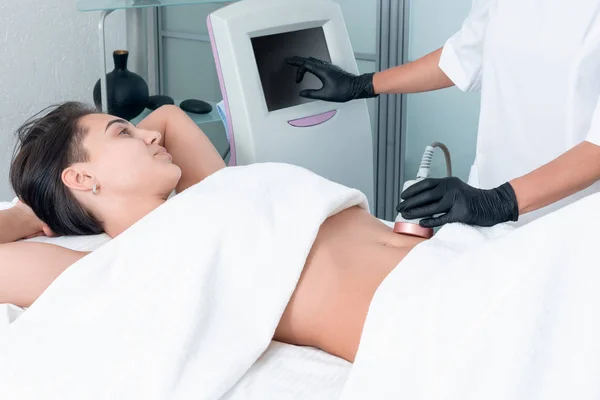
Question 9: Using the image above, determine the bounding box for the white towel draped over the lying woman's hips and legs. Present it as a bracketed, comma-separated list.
[342, 194, 600, 400]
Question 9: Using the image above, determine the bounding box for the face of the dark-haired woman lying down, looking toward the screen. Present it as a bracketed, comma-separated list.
[74, 114, 181, 197]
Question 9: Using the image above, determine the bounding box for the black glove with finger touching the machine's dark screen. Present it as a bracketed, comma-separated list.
[286, 57, 377, 103]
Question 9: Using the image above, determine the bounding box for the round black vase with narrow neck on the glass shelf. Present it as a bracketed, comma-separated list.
[94, 50, 149, 121]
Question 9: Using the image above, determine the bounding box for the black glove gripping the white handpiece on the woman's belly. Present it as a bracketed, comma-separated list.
[396, 177, 519, 228]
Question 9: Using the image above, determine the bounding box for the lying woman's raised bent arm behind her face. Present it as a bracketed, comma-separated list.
[137, 105, 225, 193]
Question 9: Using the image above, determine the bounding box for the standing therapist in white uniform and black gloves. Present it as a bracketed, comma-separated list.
[288, 0, 600, 227]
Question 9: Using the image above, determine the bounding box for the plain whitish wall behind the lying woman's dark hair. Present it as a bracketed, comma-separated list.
[0, 0, 126, 201]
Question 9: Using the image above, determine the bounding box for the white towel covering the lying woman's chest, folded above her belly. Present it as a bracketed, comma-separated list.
[0, 164, 368, 400]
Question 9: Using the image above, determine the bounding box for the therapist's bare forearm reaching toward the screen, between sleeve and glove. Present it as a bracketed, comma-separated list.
[373, 48, 454, 94]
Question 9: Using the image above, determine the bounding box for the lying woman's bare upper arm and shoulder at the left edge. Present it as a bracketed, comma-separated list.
[0, 242, 89, 307]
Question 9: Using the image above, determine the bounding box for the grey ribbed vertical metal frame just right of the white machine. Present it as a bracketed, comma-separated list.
[374, 0, 408, 221]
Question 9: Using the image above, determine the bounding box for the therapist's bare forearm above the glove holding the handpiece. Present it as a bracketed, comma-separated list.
[510, 142, 600, 214]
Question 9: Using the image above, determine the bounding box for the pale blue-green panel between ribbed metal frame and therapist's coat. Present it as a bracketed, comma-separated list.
[404, 0, 479, 180]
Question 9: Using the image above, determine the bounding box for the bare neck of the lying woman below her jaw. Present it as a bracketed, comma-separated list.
[98, 197, 166, 238]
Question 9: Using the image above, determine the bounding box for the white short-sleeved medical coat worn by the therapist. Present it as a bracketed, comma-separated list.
[439, 0, 600, 222]
